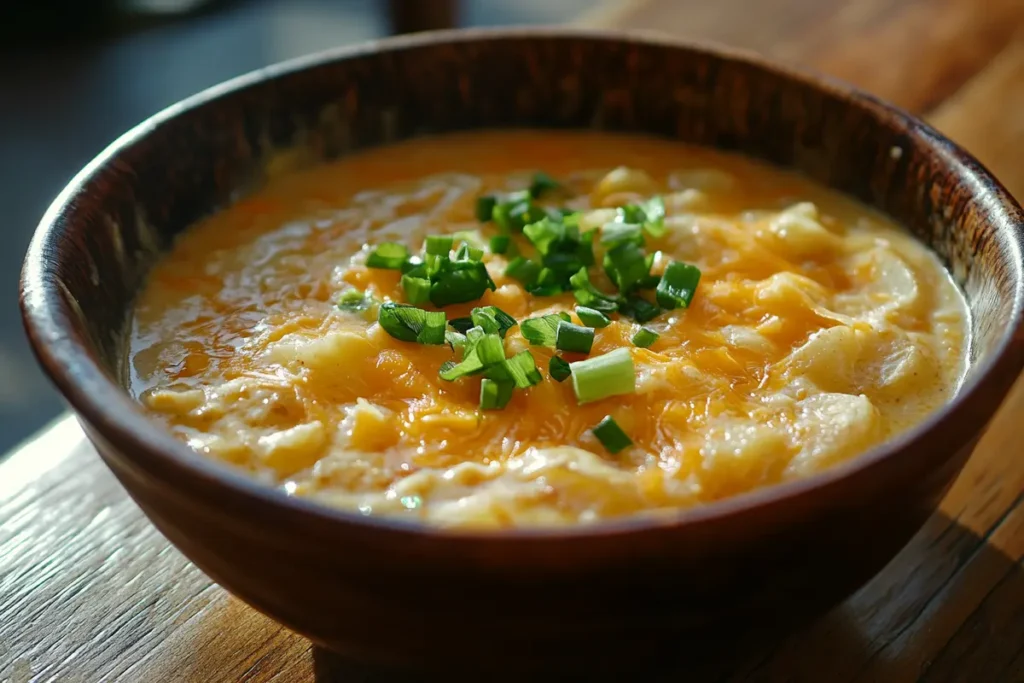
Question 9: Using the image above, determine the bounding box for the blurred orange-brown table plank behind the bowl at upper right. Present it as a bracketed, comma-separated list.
[606, 0, 1024, 112]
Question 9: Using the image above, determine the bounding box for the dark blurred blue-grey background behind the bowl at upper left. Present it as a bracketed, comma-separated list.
[0, 0, 596, 457]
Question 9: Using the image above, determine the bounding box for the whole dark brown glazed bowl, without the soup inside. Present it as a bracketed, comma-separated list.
[22, 29, 1024, 671]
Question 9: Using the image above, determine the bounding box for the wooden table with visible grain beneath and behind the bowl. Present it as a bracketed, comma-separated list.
[0, 0, 1024, 683]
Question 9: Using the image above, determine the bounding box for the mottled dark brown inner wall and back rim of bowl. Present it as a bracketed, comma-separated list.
[27, 31, 1022, 511]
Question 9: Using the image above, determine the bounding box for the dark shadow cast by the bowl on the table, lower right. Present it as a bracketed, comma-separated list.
[305, 515, 1024, 683]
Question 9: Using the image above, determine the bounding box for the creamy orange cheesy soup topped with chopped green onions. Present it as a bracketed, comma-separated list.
[129, 132, 968, 527]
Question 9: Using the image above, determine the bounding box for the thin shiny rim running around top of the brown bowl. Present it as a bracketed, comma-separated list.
[20, 27, 1024, 542]
